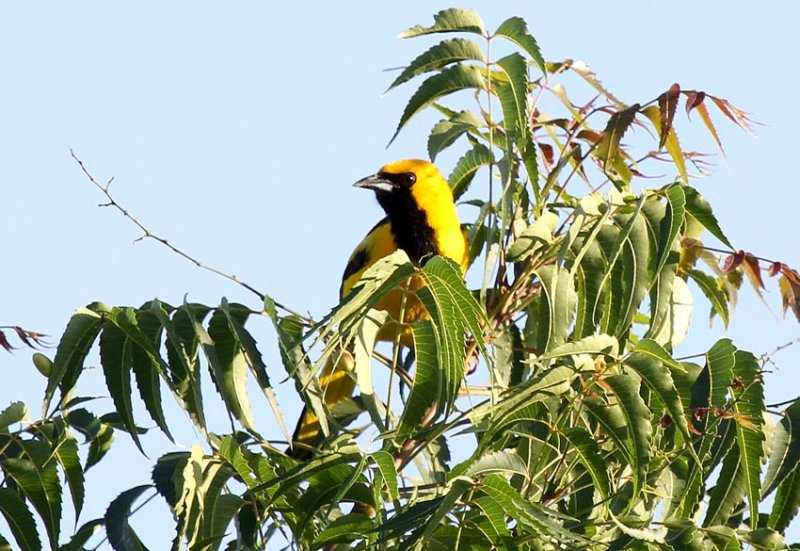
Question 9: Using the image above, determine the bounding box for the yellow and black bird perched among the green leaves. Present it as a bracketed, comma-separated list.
[290, 159, 469, 459]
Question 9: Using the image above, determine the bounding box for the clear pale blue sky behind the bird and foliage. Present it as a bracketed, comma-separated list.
[0, 0, 800, 549]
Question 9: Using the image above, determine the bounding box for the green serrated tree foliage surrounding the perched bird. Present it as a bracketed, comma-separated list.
[0, 9, 800, 549]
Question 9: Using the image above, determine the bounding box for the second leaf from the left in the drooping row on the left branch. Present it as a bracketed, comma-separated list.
[100, 322, 144, 454]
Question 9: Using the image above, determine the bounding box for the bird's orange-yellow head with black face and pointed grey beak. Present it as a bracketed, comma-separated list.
[353, 159, 453, 217]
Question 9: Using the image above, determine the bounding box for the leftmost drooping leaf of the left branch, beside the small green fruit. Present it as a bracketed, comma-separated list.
[42, 308, 103, 417]
